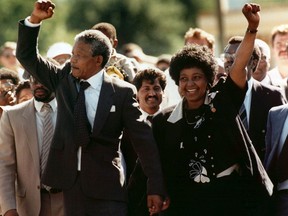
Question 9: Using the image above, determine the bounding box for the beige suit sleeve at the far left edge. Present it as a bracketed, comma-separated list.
[0, 111, 16, 215]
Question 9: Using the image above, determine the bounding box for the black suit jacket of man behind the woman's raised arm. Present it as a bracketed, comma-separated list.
[248, 80, 286, 161]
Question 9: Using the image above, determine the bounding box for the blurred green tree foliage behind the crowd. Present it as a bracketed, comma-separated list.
[0, 0, 202, 55]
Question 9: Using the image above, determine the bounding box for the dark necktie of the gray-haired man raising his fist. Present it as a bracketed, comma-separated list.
[74, 82, 91, 147]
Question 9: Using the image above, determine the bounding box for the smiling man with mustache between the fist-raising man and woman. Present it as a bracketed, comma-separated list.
[121, 68, 166, 216]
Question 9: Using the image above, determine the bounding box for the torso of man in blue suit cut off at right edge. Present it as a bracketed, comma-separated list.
[264, 104, 288, 216]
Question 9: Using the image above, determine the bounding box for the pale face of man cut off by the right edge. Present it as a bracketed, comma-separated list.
[273, 34, 288, 64]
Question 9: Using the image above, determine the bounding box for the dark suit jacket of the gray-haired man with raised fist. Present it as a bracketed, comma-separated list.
[17, 21, 164, 201]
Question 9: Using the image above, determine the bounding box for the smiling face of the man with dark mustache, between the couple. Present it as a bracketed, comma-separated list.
[137, 79, 163, 114]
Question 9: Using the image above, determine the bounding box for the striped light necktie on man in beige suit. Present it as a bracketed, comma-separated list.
[40, 103, 54, 175]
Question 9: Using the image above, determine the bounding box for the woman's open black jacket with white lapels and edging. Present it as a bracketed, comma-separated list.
[152, 76, 273, 198]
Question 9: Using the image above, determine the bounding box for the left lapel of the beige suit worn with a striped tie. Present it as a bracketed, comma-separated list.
[21, 100, 40, 174]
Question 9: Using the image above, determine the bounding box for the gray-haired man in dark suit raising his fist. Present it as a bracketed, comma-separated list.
[16, 1, 165, 216]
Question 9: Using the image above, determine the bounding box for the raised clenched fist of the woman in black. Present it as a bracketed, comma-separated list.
[242, 3, 260, 31]
